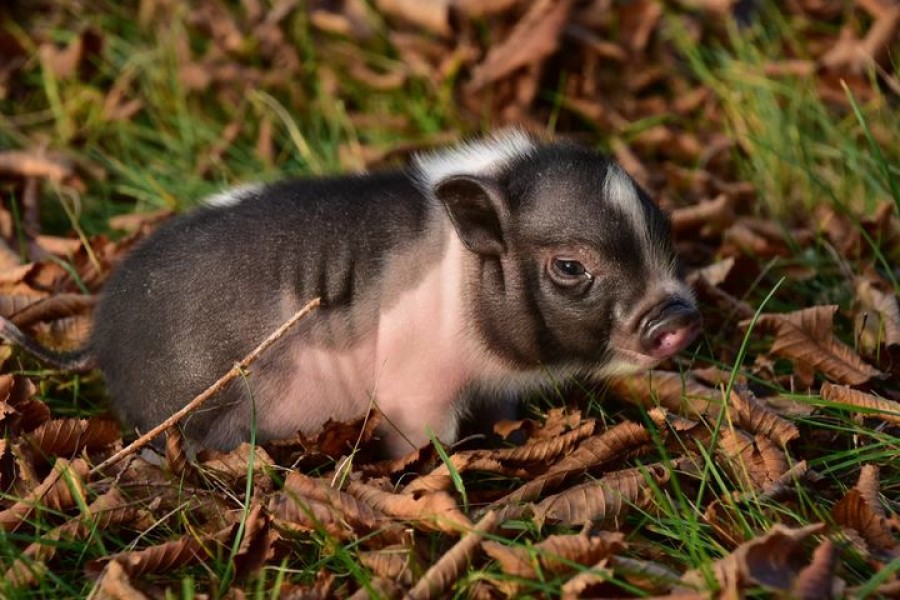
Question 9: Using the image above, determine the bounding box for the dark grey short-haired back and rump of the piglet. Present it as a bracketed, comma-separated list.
[90, 173, 436, 446]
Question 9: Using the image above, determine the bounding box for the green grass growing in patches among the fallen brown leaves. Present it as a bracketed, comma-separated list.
[0, 2, 900, 598]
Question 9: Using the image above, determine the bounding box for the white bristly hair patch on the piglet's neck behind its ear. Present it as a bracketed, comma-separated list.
[412, 128, 538, 192]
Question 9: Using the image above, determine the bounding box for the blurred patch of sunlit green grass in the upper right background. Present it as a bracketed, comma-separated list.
[669, 9, 900, 219]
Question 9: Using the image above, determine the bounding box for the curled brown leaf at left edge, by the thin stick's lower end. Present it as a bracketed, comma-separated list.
[0, 458, 90, 531]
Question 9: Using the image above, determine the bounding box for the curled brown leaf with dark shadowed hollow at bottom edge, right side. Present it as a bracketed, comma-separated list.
[682, 523, 825, 590]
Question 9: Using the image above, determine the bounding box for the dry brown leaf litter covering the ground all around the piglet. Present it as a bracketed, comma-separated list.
[0, 0, 900, 598]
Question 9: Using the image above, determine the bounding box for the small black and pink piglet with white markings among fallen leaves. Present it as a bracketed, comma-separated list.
[0, 130, 700, 456]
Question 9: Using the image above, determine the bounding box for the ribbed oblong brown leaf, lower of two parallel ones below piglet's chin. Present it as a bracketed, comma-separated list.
[534, 464, 669, 525]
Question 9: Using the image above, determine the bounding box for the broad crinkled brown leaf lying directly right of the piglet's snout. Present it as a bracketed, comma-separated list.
[741, 306, 881, 385]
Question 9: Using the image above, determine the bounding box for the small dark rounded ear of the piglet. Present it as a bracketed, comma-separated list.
[434, 175, 509, 256]
